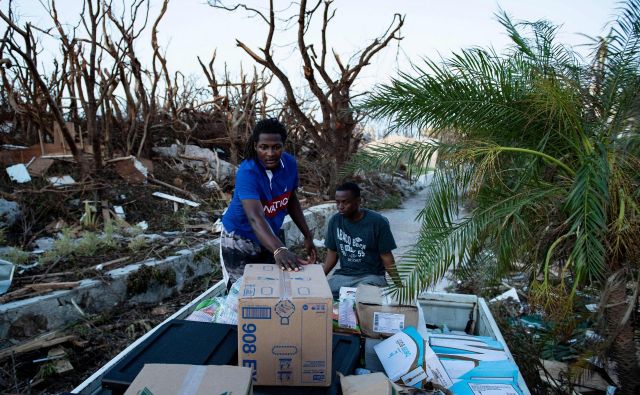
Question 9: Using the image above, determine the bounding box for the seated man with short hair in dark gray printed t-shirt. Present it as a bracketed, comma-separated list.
[324, 182, 401, 298]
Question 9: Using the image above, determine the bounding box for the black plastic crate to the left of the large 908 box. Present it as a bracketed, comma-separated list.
[102, 320, 238, 394]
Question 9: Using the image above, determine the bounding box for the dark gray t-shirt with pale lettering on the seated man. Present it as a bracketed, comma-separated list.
[324, 209, 396, 276]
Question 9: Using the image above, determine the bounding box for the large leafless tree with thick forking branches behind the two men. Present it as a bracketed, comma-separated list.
[209, 0, 404, 183]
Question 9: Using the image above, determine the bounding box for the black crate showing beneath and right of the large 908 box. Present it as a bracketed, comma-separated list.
[253, 333, 360, 395]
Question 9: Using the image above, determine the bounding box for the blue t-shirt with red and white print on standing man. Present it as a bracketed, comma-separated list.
[222, 152, 298, 243]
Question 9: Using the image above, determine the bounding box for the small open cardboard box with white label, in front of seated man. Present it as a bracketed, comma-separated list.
[356, 285, 418, 339]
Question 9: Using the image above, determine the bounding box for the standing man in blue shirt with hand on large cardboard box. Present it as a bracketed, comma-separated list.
[220, 119, 317, 285]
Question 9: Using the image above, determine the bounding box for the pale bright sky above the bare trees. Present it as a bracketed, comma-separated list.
[0, 0, 619, 102]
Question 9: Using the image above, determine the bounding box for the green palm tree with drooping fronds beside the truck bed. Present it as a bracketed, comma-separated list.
[348, 0, 640, 394]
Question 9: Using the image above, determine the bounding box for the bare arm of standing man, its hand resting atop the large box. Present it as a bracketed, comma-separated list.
[242, 199, 298, 270]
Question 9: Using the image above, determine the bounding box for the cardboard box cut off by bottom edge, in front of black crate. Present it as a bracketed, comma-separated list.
[125, 363, 253, 395]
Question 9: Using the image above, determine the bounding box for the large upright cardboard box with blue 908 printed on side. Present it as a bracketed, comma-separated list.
[238, 264, 332, 386]
